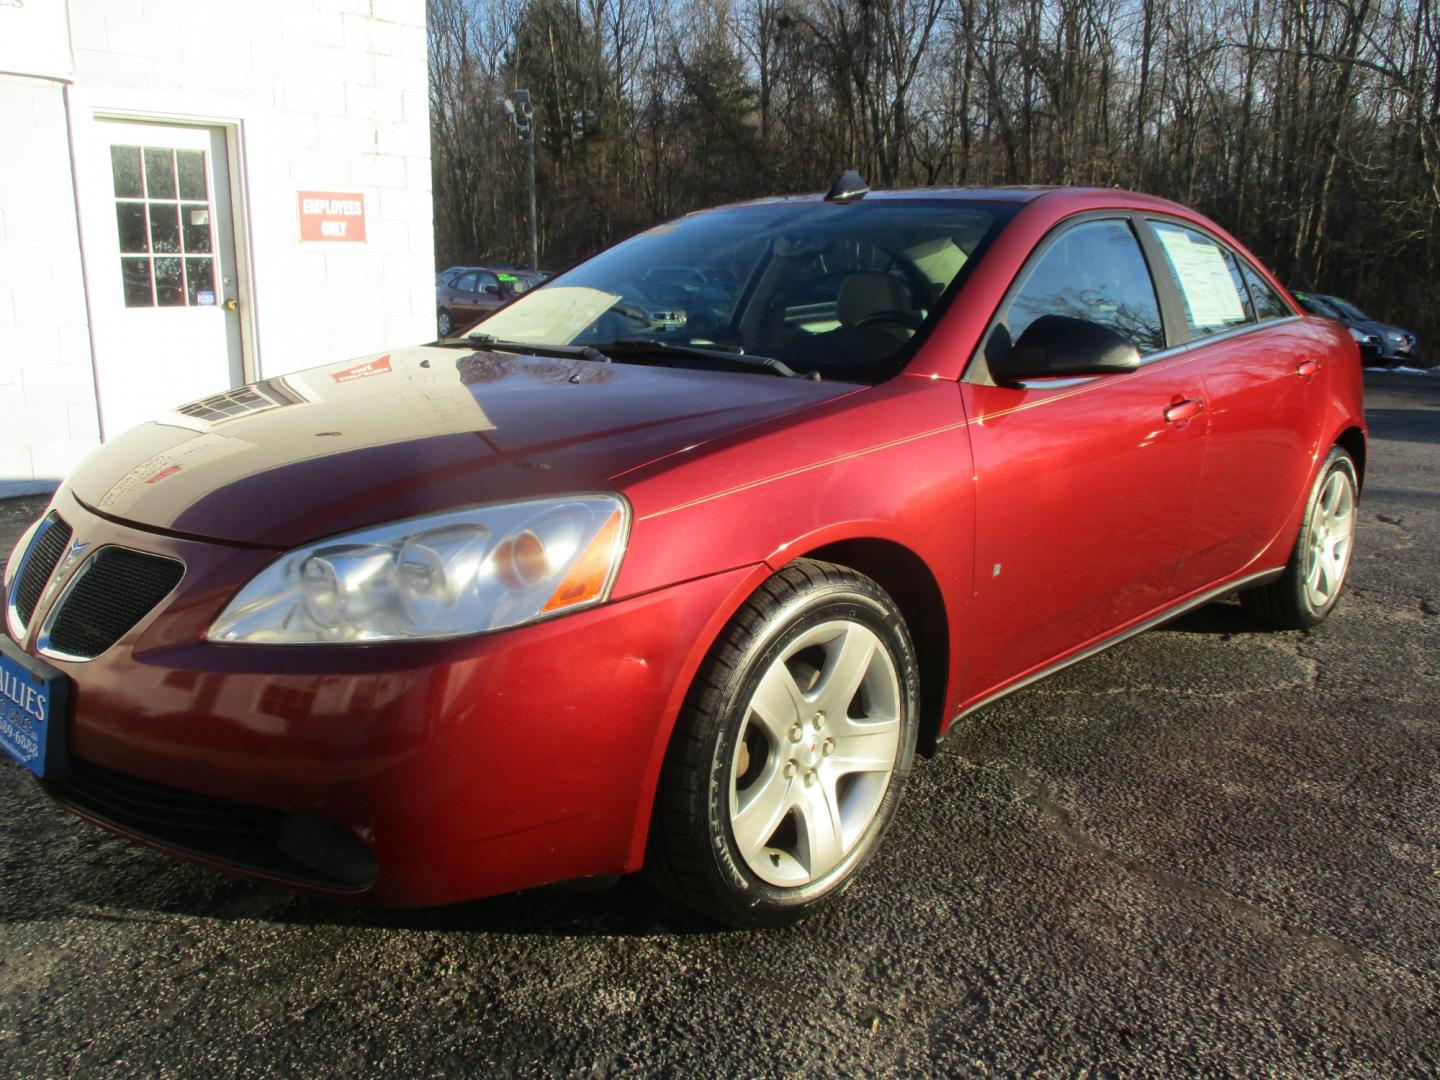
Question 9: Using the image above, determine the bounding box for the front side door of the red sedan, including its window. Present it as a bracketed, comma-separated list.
[960, 216, 1208, 694]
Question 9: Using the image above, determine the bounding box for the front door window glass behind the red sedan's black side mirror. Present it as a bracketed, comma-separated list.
[1002, 220, 1165, 353]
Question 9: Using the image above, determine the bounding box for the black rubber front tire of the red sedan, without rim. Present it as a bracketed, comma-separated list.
[704, 580, 919, 920]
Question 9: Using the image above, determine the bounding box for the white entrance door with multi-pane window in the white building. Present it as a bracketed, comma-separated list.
[82, 121, 245, 438]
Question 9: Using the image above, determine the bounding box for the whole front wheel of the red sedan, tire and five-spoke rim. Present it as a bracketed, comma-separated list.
[645, 559, 919, 926]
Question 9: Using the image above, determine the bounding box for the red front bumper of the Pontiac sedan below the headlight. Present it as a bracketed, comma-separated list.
[16, 492, 753, 906]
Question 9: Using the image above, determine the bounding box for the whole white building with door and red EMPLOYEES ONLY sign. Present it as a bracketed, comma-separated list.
[0, 0, 435, 495]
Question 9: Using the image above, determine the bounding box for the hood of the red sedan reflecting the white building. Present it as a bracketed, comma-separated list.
[66, 347, 860, 547]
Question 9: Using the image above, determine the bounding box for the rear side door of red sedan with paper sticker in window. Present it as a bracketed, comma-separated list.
[1148, 219, 1323, 595]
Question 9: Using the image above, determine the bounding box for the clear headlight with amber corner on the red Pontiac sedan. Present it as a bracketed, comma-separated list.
[206, 495, 628, 645]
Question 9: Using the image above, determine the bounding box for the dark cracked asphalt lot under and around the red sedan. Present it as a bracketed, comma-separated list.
[0, 376, 1440, 1077]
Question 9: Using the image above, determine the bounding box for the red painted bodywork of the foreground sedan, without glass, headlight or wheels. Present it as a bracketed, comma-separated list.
[5, 192, 1364, 904]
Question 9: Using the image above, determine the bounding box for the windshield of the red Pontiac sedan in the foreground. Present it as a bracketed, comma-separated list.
[480, 200, 1017, 382]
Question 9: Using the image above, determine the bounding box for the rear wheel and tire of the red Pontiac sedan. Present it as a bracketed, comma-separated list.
[1240, 446, 1359, 629]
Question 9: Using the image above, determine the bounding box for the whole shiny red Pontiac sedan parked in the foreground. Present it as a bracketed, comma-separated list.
[0, 182, 1365, 924]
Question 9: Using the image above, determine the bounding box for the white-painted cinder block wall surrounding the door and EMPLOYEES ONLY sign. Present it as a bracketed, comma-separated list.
[0, 0, 435, 495]
